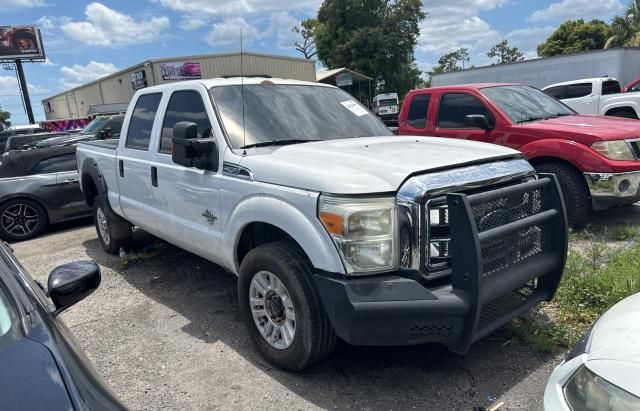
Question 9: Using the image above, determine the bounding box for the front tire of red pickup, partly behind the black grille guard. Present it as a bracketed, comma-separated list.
[536, 163, 591, 228]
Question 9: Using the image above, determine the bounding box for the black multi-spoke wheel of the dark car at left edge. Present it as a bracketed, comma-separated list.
[0, 198, 47, 241]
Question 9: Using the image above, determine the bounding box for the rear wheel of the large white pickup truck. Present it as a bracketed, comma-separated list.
[93, 196, 132, 255]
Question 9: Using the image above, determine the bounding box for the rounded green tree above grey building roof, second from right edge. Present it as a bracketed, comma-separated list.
[538, 19, 611, 57]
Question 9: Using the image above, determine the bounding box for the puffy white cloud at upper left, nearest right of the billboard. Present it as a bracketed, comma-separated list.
[62, 2, 169, 46]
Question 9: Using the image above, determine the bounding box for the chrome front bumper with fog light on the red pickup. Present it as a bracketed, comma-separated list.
[584, 171, 640, 210]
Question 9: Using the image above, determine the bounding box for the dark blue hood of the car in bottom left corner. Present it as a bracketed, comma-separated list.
[0, 338, 73, 410]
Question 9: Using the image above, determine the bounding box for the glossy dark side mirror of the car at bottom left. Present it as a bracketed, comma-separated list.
[47, 261, 101, 315]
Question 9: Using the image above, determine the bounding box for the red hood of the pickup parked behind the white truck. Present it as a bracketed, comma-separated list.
[521, 115, 640, 145]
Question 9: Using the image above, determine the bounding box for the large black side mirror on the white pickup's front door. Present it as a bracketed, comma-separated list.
[171, 121, 220, 171]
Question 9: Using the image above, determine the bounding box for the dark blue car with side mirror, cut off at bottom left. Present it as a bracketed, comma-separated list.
[0, 242, 125, 410]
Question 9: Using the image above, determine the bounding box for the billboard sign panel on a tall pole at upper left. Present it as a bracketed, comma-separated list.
[0, 26, 45, 60]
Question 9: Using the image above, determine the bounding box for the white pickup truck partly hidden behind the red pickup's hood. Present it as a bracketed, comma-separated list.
[542, 77, 640, 119]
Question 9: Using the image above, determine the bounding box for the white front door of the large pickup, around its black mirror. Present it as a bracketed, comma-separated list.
[152, 85, 222, 261]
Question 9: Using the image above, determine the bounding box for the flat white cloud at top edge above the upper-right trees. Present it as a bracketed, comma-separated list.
[529, 0, 622, 22]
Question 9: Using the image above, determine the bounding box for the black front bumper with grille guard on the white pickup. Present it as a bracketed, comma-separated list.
[314, 176, 567, 353]
